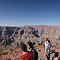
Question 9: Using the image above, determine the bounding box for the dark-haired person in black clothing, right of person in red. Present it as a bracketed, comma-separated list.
[28, 42, 38, 60]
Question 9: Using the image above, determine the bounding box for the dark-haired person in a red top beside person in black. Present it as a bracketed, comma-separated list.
[20, 44, 31, 60]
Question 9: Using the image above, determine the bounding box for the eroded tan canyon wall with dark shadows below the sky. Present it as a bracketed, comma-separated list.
[0, 26, 60, 49]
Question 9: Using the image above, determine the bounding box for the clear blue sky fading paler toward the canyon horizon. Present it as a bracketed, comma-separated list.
[0, 0, 60, 26]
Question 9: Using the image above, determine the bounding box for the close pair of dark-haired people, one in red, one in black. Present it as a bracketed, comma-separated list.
[20, 42, 38, 60]
